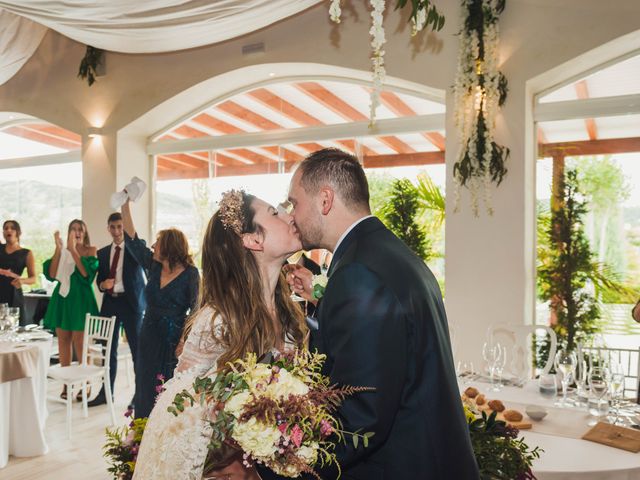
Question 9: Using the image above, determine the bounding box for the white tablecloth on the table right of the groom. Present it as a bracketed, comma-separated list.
[460, 381, 640, 480]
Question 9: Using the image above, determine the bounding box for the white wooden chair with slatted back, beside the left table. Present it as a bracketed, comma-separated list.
[48, 314, 116, 438]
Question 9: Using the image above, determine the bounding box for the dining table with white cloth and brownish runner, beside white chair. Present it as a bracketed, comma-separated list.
[0, 330, 53, 468]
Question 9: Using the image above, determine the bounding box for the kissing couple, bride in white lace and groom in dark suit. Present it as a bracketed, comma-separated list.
[134, 149, 478, 480]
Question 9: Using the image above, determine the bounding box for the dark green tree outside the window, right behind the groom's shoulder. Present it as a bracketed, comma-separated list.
[382, 178, 431, 260]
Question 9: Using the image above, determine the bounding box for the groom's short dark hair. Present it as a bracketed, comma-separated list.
[298, 148, 369, 211]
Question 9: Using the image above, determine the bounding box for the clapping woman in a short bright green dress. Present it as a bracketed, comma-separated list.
[42, 219, 99, 399]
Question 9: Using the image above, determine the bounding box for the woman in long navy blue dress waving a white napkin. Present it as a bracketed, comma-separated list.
[122, 200, 200, 418]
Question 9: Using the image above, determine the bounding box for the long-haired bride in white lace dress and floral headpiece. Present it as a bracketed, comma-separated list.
[133, 190, 307, 480]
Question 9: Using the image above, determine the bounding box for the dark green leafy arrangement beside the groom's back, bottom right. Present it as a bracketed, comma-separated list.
[469, 412, 543, 480]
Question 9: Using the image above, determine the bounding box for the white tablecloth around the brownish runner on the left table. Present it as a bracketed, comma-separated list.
[0, 339, 52, 466]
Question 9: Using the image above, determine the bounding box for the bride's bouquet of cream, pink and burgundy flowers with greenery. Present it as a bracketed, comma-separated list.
[169, 350, 373, 478]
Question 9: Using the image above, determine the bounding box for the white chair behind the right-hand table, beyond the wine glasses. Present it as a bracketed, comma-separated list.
[487, 323, 558, 378]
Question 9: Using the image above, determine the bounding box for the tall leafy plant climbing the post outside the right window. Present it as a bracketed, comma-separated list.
[538, 170, 600, 350]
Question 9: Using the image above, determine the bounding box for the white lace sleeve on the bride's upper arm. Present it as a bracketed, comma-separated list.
[176, 308, 224, 374]
